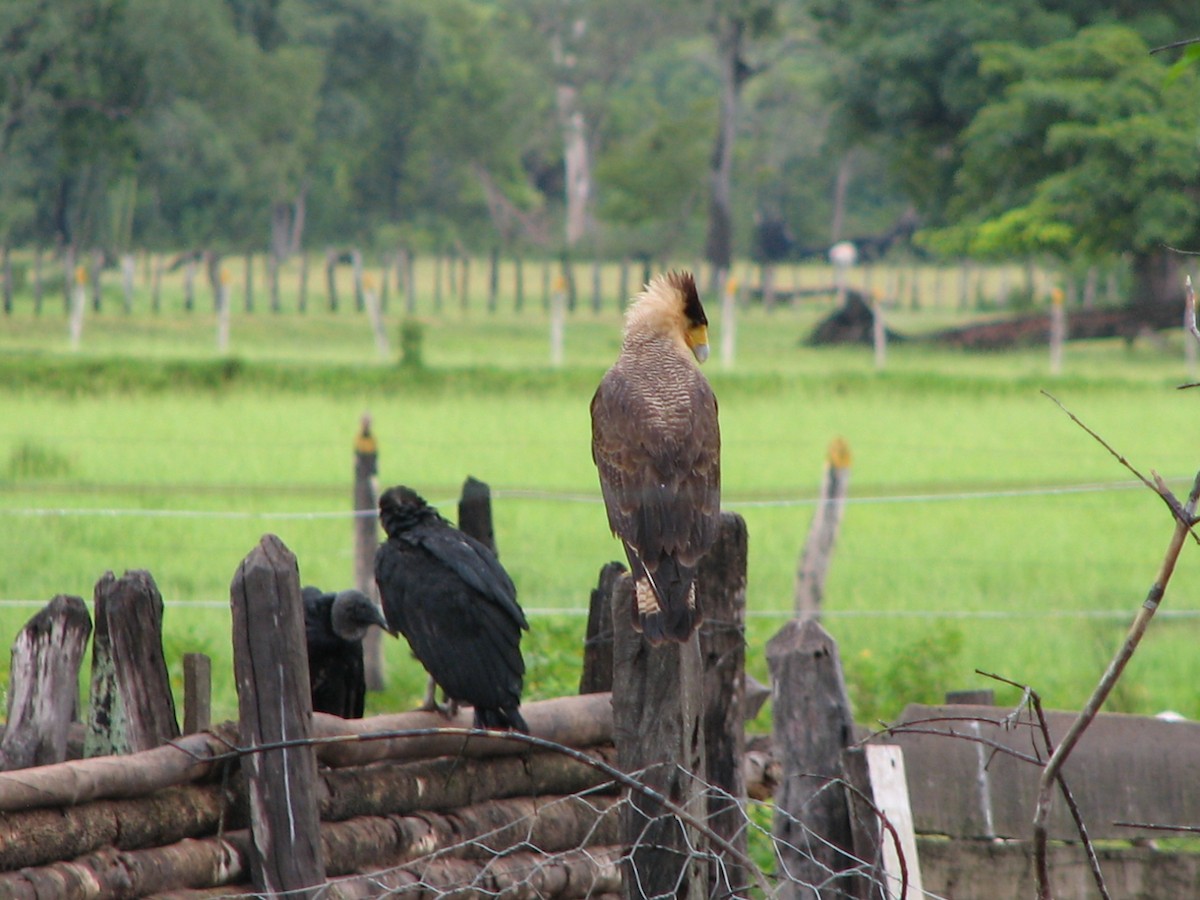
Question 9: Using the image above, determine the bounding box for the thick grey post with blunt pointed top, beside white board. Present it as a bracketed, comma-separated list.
[767, 619, 858, 900]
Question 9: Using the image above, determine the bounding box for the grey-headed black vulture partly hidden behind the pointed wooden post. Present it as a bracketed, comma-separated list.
[301, 587, 395, 719]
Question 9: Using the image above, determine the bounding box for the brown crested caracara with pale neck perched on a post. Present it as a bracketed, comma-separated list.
[592, 272, 721, 643]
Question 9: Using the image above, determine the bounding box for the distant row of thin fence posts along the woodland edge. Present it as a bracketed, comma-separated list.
[0, 248, 1104, 316]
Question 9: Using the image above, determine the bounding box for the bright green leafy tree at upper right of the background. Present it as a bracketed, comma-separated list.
[934, 25, 1200, 314]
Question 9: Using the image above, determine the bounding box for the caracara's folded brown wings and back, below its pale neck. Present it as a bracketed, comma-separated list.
[592, 365, 721, 572]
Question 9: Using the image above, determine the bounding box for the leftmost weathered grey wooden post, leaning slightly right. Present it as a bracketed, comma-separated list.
[0, 594, 91, 769]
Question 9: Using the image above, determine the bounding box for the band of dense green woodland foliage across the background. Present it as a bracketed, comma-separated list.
[11, 0, 1200, 285]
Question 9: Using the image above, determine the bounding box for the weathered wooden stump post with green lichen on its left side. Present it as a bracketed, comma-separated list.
[84, 570, 179, 756]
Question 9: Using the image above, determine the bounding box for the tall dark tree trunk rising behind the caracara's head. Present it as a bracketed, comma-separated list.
[704, 14, 745, 289]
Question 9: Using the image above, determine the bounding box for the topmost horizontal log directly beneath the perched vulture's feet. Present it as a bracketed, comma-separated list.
[314, 691, 628, 768]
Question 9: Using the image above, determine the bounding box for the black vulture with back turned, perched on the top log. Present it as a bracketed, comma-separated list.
[376, 486, 529, 732]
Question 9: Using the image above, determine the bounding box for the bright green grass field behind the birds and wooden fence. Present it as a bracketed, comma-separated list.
[0, 262, 1200, 734]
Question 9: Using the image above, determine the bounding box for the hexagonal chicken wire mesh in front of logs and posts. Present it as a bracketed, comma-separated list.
[253, 773, 934, 900]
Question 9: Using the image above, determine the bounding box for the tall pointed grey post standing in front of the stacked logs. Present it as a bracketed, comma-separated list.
[229, 534, 325, 898]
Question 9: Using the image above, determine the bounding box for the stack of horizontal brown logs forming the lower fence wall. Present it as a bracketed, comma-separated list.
[0, 694, 622, 900]
